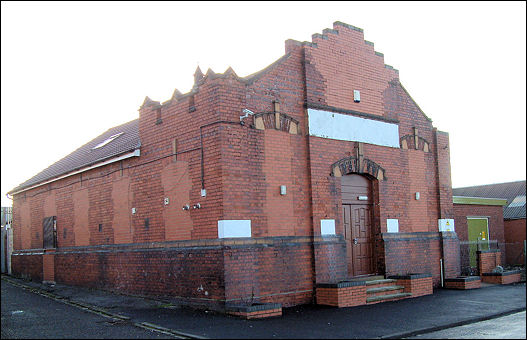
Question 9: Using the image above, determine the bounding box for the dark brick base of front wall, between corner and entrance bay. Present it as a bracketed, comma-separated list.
[224, 237, 313, 307]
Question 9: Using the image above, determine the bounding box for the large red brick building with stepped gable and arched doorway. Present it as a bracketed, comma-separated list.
[10, 22, 459, 306]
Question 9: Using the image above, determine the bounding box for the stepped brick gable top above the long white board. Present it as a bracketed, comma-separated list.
[305, 23, 398, 116]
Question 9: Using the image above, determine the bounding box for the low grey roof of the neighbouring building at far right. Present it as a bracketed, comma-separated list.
[452, 181, 525, 219]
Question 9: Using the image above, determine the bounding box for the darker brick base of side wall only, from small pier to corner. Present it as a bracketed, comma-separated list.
[55, 240, 224, 304]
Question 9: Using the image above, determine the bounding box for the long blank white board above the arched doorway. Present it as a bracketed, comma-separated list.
[307, 109, 399, 148]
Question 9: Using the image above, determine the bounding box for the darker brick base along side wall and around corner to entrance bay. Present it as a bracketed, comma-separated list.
[12, 237, 315, 311]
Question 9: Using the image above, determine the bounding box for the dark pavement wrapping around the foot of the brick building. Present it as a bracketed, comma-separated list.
[2, 275, 526, 339]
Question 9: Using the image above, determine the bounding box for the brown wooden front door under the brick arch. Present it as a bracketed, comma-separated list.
[342, 175, 374, 276]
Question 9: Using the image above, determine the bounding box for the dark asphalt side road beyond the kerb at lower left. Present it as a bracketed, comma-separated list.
[1, 280, 174, 339]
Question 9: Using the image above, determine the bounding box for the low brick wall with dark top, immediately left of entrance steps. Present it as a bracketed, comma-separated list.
[316, 281, 366, 307]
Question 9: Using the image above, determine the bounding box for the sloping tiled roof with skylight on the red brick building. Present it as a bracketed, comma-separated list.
[9, 119, 141, 193]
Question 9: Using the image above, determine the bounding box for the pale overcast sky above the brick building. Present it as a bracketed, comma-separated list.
[1, 1, 526, 206]
